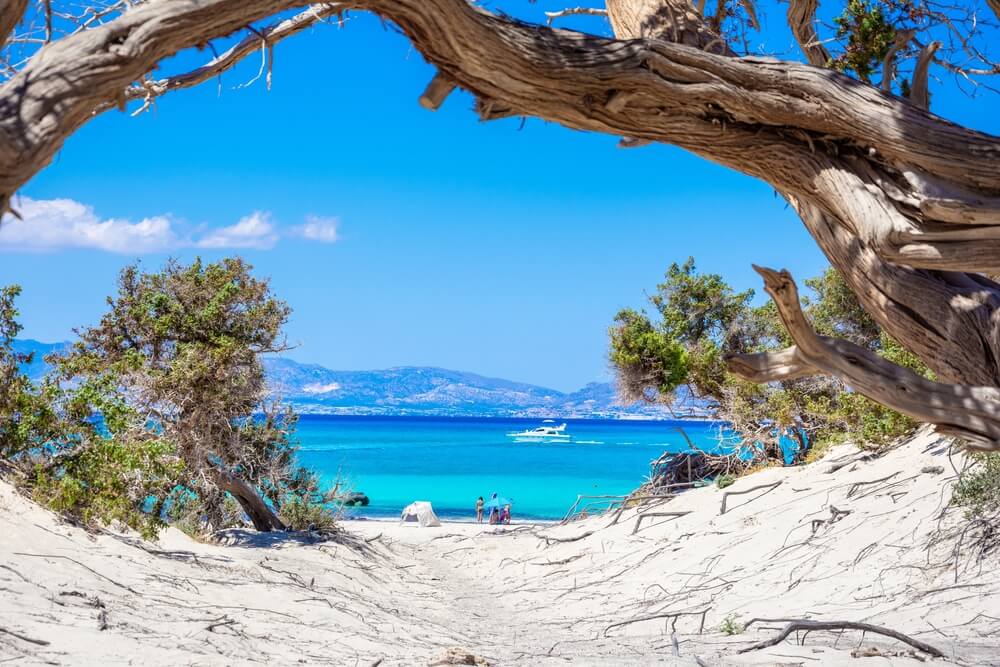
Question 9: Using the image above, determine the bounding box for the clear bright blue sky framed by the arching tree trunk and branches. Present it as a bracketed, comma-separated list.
[0, 3, 1000, 390]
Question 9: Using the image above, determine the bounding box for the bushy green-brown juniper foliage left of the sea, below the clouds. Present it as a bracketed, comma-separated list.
[55, 259, 321, 530]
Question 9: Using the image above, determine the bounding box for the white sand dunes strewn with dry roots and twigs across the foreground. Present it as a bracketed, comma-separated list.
[0, 434, 1000, 667]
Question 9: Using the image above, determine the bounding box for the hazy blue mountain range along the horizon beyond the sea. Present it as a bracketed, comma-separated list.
[15, 340, 708, 418]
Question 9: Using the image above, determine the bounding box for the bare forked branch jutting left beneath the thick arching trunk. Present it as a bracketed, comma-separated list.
[728, 266, 1000, 450]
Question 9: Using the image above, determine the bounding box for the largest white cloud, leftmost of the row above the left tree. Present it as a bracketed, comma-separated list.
[0, 197, 178, 254]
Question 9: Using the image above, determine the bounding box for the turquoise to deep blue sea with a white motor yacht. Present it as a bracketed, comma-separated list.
[298, 415, 724, 520]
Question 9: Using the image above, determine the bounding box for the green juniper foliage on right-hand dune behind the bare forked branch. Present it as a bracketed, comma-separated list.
[609, 258, 927, 460]
